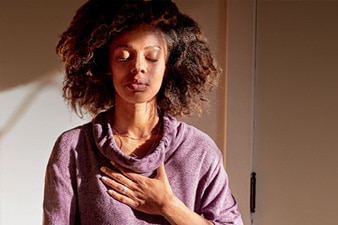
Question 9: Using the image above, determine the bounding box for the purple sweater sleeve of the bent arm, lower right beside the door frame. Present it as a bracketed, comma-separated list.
[201, 152, 243, 225]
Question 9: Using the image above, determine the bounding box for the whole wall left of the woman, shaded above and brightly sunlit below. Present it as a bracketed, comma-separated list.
[0, 0, 88, 225]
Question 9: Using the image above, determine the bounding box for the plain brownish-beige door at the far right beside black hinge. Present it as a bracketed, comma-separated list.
[253, 0, 338, 225]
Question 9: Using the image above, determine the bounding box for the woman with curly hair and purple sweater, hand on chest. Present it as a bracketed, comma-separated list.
[44, 0, 242, 225]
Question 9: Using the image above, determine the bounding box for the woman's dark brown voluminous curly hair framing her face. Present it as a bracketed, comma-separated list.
[56, 0, 221, 116]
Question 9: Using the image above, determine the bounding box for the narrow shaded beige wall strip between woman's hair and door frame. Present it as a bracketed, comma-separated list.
[175, 0, 226, 151]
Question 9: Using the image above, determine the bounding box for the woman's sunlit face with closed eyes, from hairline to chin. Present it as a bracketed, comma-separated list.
[110, 26, 167, 107]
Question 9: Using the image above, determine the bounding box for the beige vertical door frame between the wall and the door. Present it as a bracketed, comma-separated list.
[225, 0, 256, 224]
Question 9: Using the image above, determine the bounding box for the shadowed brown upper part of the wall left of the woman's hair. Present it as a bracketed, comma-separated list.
[0, 0, 84, 91]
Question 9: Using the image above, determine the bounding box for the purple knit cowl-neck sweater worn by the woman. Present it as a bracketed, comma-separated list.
[43, 110, 243, 225]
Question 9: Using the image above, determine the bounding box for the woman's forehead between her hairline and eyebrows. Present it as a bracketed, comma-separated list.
[110, 25, 167, 50]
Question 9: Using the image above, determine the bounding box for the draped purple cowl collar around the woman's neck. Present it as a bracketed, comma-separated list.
[92, 109, 171, 176]
